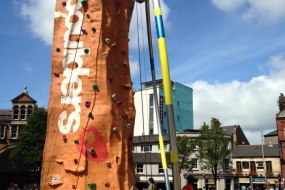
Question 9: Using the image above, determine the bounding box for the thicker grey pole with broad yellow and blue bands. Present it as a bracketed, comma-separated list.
[153, 0, 181, 190]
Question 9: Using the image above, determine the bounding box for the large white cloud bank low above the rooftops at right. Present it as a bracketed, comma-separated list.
[189, 54, 285, 143]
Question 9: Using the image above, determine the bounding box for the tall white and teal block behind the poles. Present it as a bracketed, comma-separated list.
[134, 80, 193, 136]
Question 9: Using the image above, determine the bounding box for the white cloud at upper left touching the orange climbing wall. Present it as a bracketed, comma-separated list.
[17, 0, 55, 45]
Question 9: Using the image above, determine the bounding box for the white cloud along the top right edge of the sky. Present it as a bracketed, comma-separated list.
[212, 0, 285, 23]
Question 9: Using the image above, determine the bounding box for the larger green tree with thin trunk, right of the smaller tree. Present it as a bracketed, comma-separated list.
[195, 118, 232, 189]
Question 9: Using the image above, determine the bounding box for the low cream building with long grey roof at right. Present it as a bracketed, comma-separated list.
[232, 144, 281, 189]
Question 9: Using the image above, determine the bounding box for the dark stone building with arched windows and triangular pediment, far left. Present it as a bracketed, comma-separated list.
[0, 87, 37, 189]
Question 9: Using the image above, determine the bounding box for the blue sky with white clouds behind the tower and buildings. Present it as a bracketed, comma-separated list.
[0, 0, 285, 144]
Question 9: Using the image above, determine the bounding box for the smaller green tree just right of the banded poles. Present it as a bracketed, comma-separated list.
[177, 136, 195, 172]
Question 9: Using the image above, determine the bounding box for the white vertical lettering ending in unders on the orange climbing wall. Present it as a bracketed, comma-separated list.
[55, 0, 89, 134]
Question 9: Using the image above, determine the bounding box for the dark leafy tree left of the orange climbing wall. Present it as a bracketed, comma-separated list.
[10, 107, 47, 172]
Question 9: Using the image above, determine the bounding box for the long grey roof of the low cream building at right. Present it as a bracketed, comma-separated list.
[232, 144, 280, 158]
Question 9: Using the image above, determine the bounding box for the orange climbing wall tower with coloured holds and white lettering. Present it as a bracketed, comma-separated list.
[41, 0, 135, 190]
